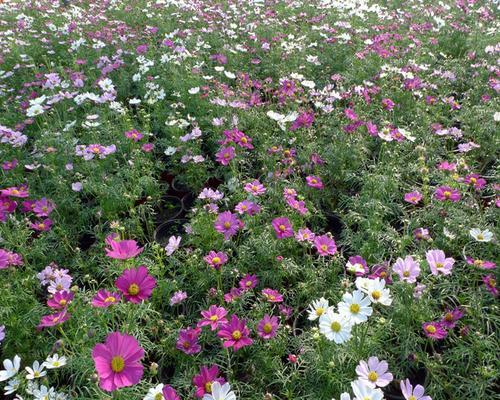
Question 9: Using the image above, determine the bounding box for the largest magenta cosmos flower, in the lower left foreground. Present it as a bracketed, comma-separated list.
[92, 332, 144, 392]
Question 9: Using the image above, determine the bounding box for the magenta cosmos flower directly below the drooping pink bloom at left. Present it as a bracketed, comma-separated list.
[115, 265, 156, 304]
